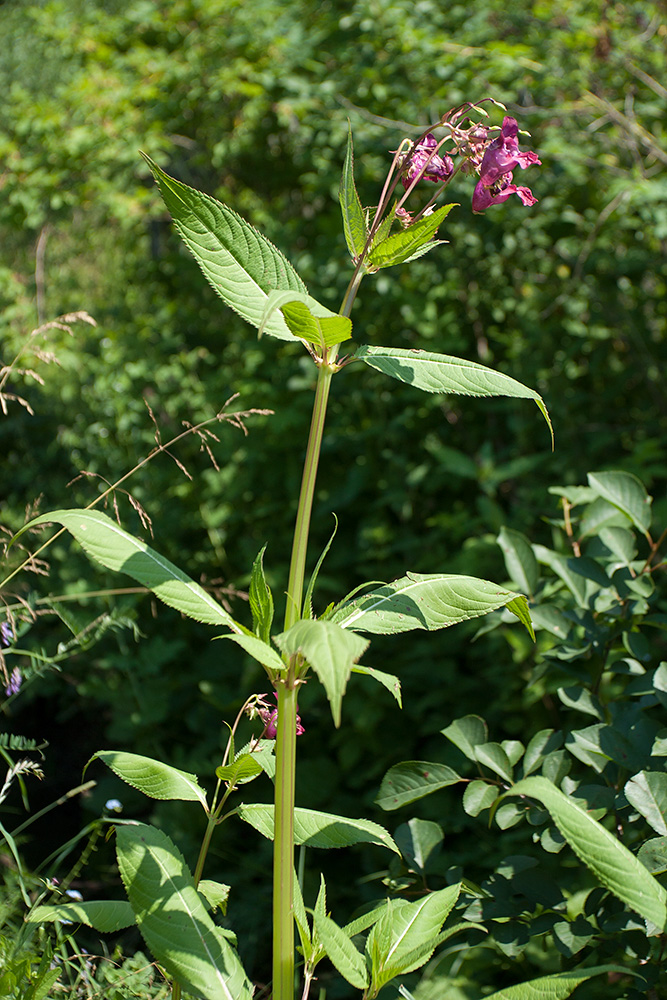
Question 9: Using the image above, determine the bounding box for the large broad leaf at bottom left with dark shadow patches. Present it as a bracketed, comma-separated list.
[116, 823, 252, 1000]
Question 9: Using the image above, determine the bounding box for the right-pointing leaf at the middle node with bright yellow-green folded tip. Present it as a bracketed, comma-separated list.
[331, 573, 534, 638]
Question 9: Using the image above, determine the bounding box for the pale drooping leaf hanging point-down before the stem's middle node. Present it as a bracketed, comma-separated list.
[274, 619, 368, 726]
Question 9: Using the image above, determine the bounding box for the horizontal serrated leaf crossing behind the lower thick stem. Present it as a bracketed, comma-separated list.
[237, 803, 400, 854]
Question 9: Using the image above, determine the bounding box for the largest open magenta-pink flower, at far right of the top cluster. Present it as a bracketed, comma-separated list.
[472, 116, 541, 212]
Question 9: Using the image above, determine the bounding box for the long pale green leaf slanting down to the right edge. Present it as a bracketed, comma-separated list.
[506, 777, 667, 931]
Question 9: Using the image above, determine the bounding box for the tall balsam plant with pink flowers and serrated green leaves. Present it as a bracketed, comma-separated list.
[11, 102, 620, 1000]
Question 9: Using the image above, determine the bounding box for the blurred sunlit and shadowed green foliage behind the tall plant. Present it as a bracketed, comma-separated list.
[0, 0, 667, 992]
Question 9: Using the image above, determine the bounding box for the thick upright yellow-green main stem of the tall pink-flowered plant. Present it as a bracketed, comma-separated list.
[273, 269, 362, 1000]
